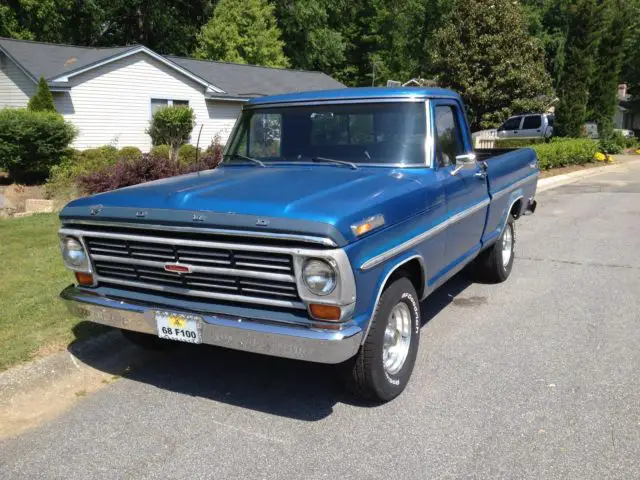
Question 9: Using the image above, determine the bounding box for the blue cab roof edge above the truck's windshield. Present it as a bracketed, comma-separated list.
[247, 87, 460, 108]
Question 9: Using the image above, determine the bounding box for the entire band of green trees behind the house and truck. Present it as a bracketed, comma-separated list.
[0, 0, 640, 135]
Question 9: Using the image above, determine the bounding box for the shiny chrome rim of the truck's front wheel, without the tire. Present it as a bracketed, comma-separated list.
[382, 302, 411, 375]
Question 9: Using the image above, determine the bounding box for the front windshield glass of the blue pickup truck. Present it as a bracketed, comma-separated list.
[225, 102, 426, 165]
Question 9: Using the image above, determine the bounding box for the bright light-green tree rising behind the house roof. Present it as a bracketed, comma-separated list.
[195, 0, 289, 67]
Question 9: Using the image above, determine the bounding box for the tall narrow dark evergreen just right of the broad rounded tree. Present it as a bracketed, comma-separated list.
[555, 0, 602, 137]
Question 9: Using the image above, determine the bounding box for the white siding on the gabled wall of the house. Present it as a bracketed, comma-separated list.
[54, 53, 241, 151]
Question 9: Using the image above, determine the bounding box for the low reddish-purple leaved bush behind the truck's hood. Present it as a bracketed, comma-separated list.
[77, 145, 223, 195]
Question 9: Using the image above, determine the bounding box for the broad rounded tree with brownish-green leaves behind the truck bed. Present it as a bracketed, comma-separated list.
[433, 0, 552, 130]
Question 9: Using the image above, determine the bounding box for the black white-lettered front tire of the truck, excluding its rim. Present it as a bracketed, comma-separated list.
[342, 277, 421, 402]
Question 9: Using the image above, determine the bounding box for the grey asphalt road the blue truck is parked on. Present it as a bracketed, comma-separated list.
[0, 165, 640, 479]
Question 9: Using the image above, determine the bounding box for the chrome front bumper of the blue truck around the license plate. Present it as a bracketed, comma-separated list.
[60, 285, 363, 363]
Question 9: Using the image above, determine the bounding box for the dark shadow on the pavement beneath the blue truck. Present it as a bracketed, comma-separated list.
[69, 275, 471, 421]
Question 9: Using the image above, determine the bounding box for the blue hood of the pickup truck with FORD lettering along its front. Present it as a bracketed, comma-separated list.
[60, 165, 426, 245]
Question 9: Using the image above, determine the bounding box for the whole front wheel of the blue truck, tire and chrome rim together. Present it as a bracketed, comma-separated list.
[343, 278, 420, 402]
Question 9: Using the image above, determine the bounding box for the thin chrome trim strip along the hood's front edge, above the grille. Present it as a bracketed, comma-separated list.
[63, 219, 338, 247]
